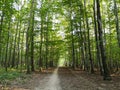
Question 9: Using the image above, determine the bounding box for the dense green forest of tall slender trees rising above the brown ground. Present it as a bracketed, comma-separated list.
[0, 0, 120, 90]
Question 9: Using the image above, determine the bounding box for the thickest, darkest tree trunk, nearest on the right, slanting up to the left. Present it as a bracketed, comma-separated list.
[96, 0, 111, 80]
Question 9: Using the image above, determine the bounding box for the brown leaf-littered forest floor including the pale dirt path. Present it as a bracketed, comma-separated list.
[0, 67, 120, 90]
